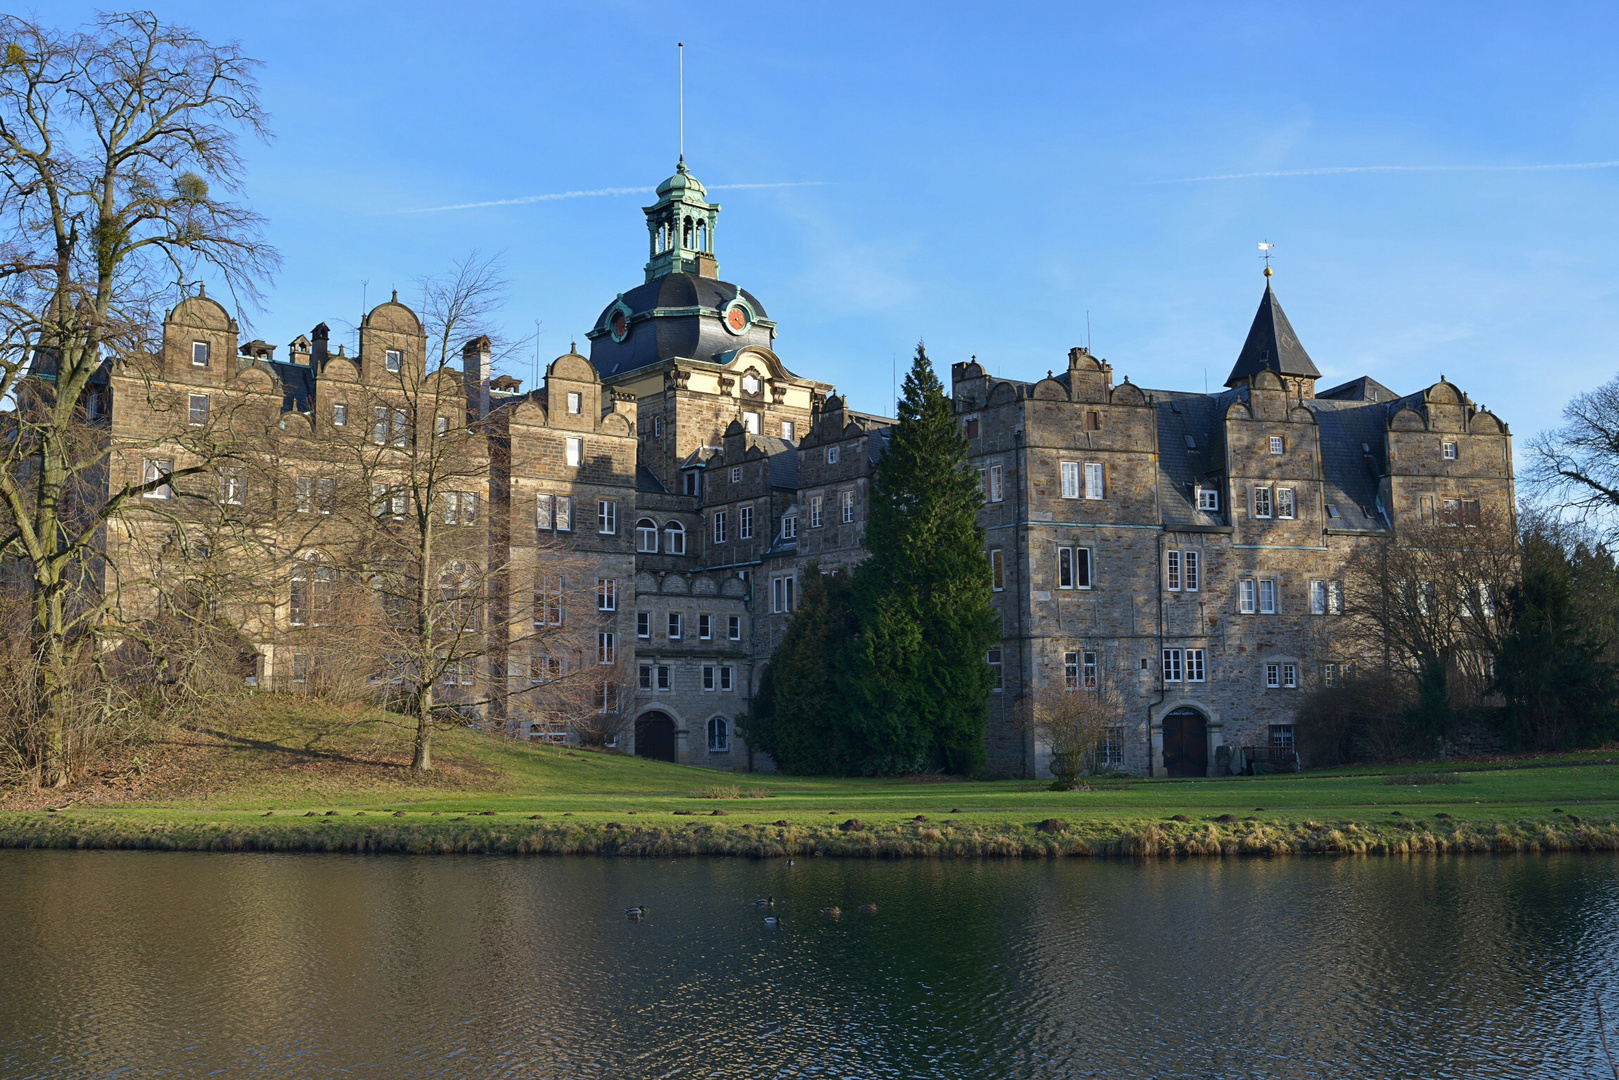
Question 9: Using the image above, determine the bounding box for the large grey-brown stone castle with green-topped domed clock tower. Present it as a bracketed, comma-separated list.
[91, 164, 1514, 776]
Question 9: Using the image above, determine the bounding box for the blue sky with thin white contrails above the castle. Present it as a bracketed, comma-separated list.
[37, 0, 1619, 436]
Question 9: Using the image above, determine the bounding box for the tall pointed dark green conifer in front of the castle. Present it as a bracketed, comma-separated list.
[839, 345, 997, 774]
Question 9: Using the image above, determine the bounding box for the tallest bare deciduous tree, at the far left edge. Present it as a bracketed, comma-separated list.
[0, 13, 277, 785]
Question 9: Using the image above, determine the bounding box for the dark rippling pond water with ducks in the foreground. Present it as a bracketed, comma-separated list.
[0, 852, 1619, 1080]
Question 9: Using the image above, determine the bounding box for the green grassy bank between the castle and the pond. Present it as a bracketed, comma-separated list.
[0, 699, 1619, 858]
